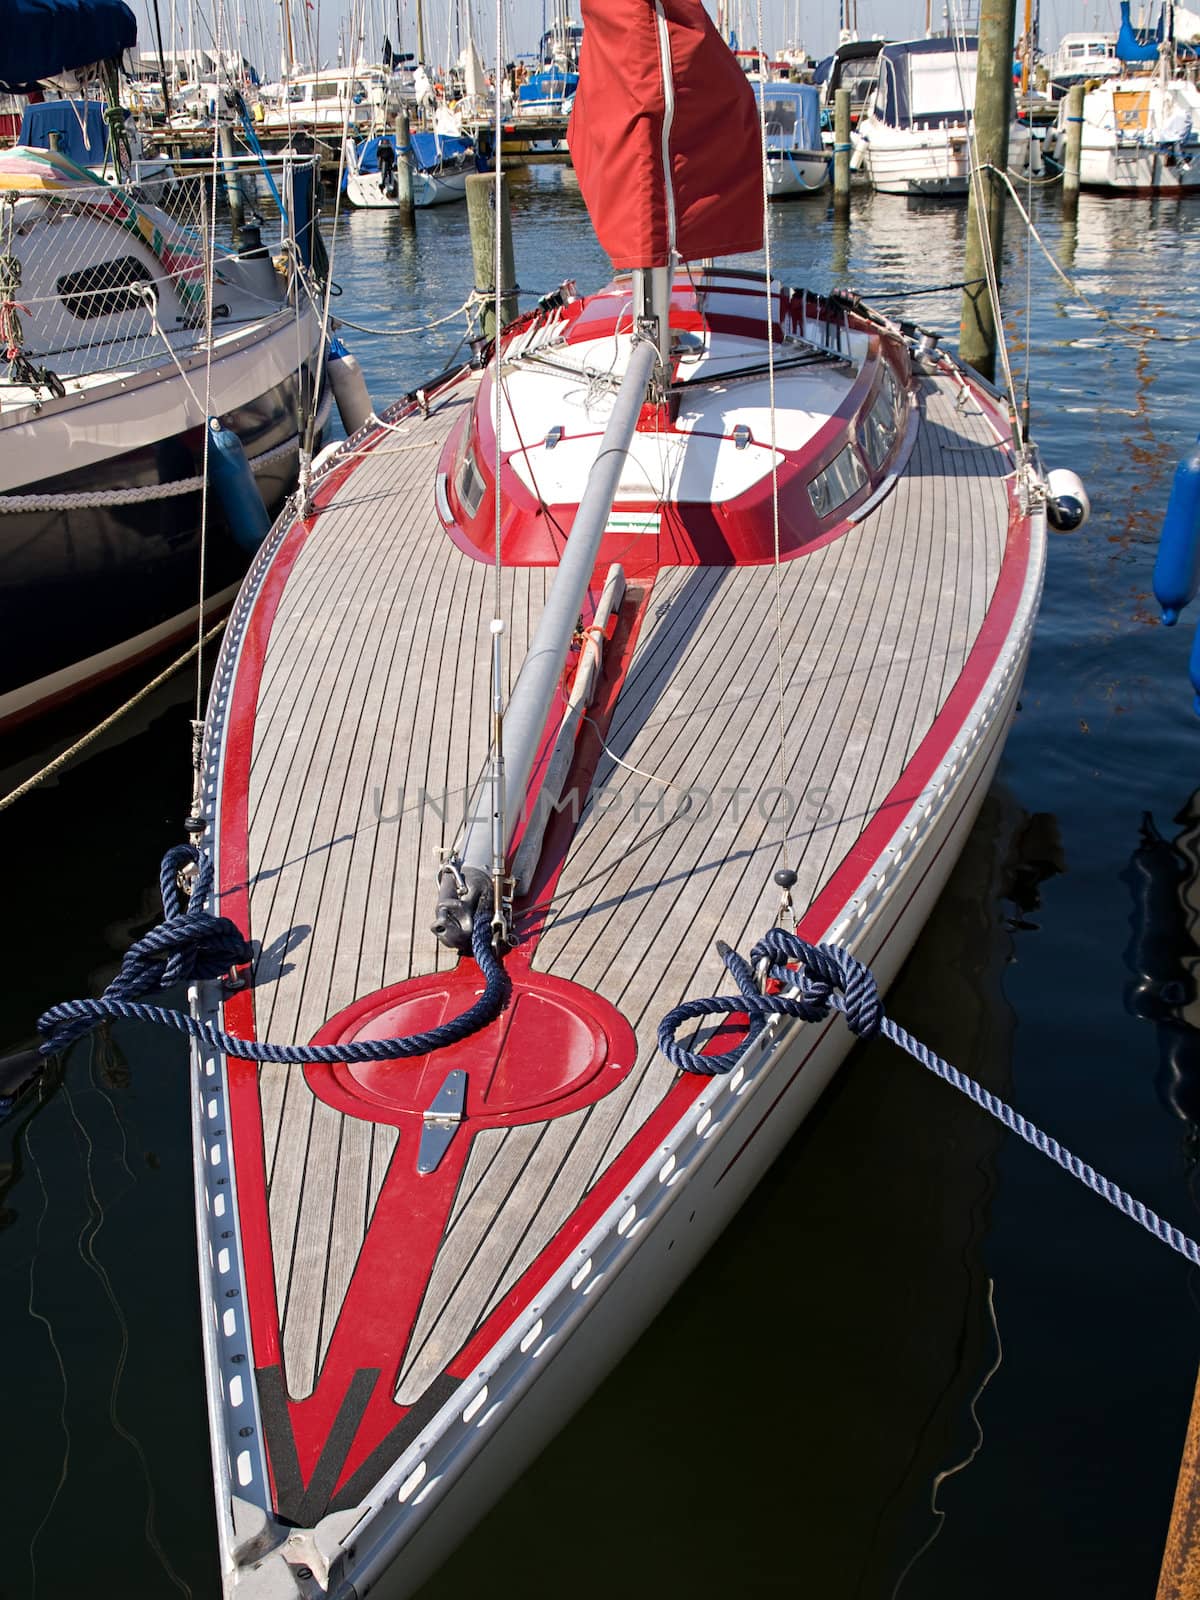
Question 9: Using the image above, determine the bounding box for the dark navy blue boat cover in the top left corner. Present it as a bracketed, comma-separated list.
[0, 0, 138, 94]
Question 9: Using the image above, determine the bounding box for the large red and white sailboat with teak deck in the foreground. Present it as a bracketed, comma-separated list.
[194, 0, 1046, 1600]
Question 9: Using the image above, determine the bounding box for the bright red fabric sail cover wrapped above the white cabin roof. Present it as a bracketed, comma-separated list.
[566, 0, 763, 267]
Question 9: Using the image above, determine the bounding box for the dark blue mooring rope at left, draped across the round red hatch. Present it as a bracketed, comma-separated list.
[37, 845, 510, 1066]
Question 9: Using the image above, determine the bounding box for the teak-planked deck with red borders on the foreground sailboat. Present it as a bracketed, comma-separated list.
[195, 272, 1035, 1587]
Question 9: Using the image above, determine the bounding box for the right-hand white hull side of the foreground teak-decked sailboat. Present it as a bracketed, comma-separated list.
[334, 633, 1032, 1600]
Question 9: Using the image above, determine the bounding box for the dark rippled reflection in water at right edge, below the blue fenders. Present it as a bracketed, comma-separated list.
[1123, 789, 1200, 1139]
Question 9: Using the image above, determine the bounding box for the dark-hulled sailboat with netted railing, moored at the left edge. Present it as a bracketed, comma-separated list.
[0, 3, 330, 728]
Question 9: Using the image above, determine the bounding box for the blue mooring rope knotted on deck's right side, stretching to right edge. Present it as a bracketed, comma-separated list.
[658, 928, 1200, 1266]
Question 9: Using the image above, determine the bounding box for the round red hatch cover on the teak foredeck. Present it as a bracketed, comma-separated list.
[306, 958, 637, 1131]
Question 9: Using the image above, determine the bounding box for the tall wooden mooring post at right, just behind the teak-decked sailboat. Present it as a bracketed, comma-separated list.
[958, 0, 1016, 379]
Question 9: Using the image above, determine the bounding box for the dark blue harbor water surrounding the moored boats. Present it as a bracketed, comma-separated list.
[0, 168, 1200, 1600]
